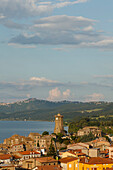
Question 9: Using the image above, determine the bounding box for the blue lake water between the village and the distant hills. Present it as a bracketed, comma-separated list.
[0, 121, 67, 143]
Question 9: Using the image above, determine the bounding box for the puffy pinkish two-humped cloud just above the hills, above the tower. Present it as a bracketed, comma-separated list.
[47, 87, 70, 101]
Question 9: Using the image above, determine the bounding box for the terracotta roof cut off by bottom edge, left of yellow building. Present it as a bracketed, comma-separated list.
[37, 165, 62, 170]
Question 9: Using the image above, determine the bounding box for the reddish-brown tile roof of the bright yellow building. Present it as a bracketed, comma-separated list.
[80, 157, 113, 164]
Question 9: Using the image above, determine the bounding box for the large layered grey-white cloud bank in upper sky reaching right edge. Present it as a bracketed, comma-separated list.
[9, 15, 113, 50]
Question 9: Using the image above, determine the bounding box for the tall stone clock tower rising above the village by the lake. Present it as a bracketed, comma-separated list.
[54, 113, 64, 134]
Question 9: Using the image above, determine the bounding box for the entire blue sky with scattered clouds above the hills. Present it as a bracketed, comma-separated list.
[0, 0, 113, 102]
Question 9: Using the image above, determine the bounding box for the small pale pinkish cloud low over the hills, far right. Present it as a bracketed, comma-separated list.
[85, 93, 105, 102]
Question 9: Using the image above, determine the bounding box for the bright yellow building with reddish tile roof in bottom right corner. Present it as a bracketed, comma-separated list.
[67, 157, 113, 170]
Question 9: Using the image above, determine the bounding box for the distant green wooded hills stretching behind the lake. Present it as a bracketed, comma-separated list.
[0, 98, 113, 122]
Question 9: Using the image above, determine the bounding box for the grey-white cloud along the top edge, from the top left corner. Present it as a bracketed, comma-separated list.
[0, 0, 87, 18]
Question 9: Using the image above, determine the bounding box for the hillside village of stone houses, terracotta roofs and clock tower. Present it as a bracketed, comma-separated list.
[0, 113, 113, 170]
